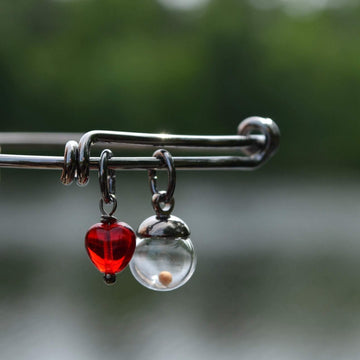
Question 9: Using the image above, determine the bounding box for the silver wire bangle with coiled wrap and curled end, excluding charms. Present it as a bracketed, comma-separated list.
[0, 117, 280, 181]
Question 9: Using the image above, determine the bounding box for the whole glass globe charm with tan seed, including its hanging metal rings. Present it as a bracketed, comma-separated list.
[130, 150, 196, 291]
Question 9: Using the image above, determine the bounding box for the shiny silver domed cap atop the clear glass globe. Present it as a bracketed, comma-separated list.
[137, 215, 190, 239]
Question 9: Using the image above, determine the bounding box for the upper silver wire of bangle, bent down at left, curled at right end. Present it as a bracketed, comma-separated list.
[77, 117, 280, 185]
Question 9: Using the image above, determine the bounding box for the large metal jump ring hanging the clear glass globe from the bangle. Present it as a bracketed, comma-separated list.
[148, 149, 176, 203]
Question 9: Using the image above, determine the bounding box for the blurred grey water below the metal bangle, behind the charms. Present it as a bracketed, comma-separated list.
[0, 170, 360, 360]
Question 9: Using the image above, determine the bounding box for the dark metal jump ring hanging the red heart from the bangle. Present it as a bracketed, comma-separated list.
[98, 149, 116, 204]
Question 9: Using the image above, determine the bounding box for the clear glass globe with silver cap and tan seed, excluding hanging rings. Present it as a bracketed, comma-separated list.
[130, 216, 196, 291]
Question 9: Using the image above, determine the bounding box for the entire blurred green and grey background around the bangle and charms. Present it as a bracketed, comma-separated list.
[0, 0, 360, 360]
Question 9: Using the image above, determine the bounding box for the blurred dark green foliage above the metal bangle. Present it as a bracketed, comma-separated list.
[0, 0, 360, 169]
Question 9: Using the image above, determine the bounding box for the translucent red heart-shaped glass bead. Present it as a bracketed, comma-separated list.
[85, 222, 136, 274]
